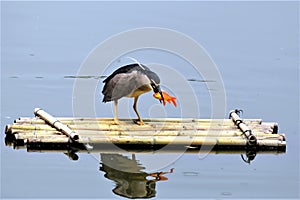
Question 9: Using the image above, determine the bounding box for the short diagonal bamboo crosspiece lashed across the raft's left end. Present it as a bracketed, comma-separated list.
[34, 108, 78, 140]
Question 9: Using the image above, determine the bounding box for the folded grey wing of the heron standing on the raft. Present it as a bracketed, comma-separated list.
[102, 71, 140, 102]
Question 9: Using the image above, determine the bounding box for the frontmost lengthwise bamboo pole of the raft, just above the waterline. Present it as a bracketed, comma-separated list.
[16, 136, 286, 150]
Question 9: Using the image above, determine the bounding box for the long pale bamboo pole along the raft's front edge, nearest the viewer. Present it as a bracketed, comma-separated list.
[22, 135, 286, 147]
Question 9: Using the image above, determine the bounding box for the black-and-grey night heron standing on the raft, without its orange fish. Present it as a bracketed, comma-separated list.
[102, 63, 165, 125]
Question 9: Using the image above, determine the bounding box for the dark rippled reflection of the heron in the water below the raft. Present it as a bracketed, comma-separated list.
[100, 154, 173, 199]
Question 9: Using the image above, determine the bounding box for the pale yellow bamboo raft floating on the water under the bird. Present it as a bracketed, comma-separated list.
[5, 108, 286, 162]
